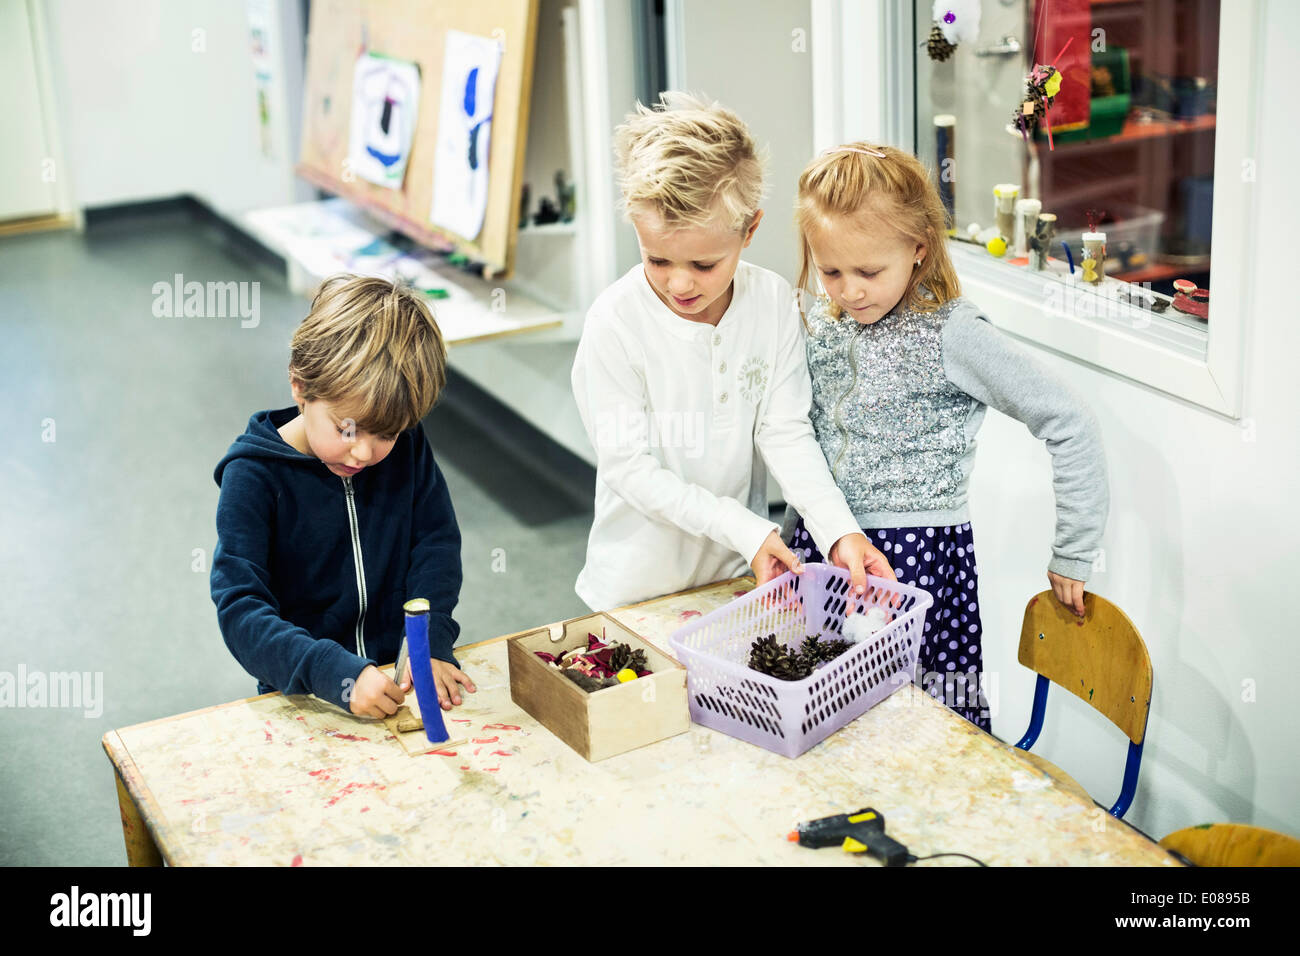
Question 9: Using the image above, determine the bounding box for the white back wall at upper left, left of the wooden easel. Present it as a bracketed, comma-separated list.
[46, 0, 311, 217]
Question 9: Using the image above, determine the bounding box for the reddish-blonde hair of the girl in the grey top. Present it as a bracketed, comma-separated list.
[794, 143, 962, 319]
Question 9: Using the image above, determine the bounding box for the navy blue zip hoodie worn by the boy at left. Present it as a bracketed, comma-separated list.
[211, 407, 462, 710]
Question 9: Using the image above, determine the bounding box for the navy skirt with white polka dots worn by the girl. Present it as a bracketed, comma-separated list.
[787, 519, 992, 732]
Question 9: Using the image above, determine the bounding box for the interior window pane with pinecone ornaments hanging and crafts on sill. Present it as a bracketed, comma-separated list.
[914, 0, 1219, 329]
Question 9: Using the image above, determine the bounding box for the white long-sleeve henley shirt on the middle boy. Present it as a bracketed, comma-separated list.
[572, 261, 859, 610]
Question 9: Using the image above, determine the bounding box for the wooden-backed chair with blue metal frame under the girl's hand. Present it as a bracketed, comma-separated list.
[1015, 591, 1152, 818]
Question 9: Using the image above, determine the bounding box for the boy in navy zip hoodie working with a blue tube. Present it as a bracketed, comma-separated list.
[211, 276, 475, 718]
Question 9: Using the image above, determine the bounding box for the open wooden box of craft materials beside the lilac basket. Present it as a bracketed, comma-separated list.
[507, 614, 690, 762]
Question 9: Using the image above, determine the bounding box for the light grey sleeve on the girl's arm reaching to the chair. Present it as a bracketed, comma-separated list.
[943, 308, 1110, 581]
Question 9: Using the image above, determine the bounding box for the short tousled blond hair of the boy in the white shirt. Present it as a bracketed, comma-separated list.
[614, 91, 764, 232]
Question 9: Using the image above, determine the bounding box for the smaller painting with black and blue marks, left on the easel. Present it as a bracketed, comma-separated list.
[347, 53, 420, 189]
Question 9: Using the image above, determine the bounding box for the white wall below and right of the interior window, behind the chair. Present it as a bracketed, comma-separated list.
[951, 3, 1300, 838]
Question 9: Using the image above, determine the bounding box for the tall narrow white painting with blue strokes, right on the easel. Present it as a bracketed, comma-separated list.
[429, 30, 501, 239]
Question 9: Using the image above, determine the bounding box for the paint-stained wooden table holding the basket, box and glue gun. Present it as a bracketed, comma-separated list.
[104, 579, 1174, 866]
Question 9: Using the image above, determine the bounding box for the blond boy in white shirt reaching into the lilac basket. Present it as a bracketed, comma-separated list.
[572, 92, 894, 610]
